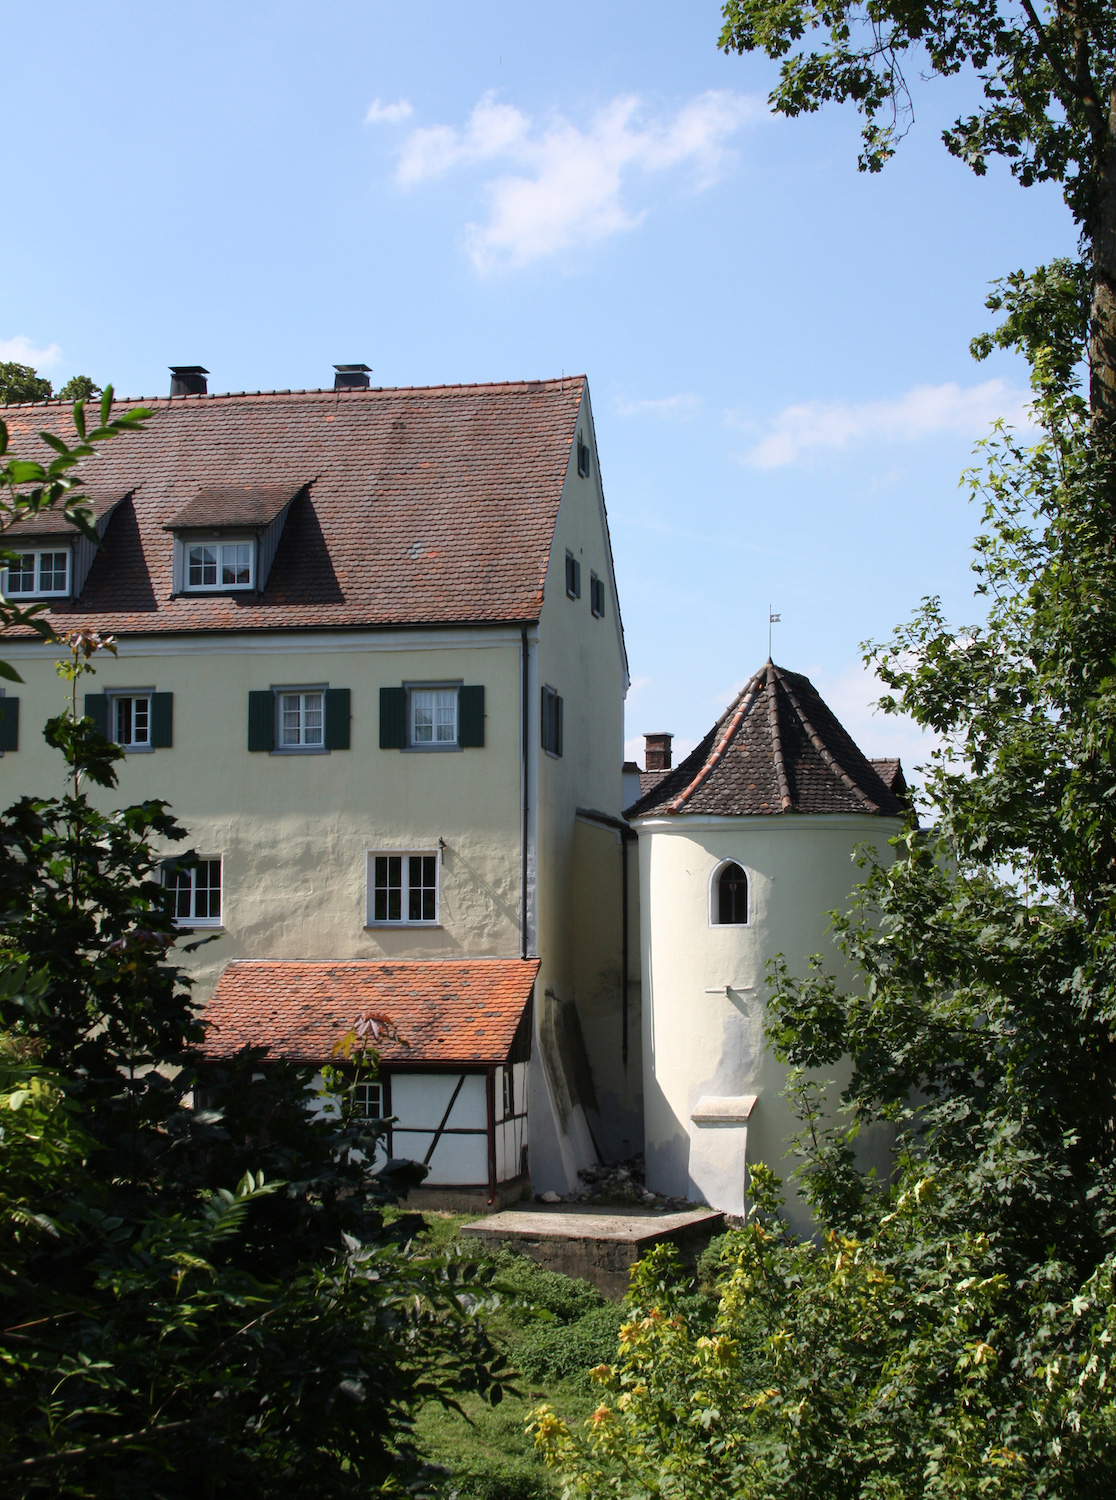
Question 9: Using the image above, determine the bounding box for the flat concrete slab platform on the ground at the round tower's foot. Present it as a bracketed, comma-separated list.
[461, 1208, 725, 1298]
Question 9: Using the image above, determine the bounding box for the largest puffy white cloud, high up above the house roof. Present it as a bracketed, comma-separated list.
[396, 90, 765, 270]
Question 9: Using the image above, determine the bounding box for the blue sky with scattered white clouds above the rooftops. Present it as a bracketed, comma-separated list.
[0, 0, 1074, 762]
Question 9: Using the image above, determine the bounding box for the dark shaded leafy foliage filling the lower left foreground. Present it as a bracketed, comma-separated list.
[0, 635, 503, 1500]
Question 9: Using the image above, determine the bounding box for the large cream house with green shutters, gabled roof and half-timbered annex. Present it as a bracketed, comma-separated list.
[0, 368, 641, 1200]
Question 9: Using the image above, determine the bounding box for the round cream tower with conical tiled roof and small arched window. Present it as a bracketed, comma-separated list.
[627, 662, 906, 1230]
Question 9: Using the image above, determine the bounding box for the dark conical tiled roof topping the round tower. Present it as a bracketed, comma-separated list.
[626, 662, 903, 818]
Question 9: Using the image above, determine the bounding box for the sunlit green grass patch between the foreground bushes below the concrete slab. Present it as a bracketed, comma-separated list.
[405, 1214, 623, 1500]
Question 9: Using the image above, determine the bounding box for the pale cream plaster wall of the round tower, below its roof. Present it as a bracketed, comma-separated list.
[638, 815, 900, 1230]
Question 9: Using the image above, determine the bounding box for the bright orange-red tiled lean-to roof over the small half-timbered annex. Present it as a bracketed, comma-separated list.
[203, 959, 540, 1064]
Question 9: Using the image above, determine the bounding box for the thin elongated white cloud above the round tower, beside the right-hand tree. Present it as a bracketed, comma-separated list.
[729, 380, 1031, 468]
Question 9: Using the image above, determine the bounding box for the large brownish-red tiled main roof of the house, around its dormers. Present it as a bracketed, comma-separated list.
[0, 377, 585, 635]
